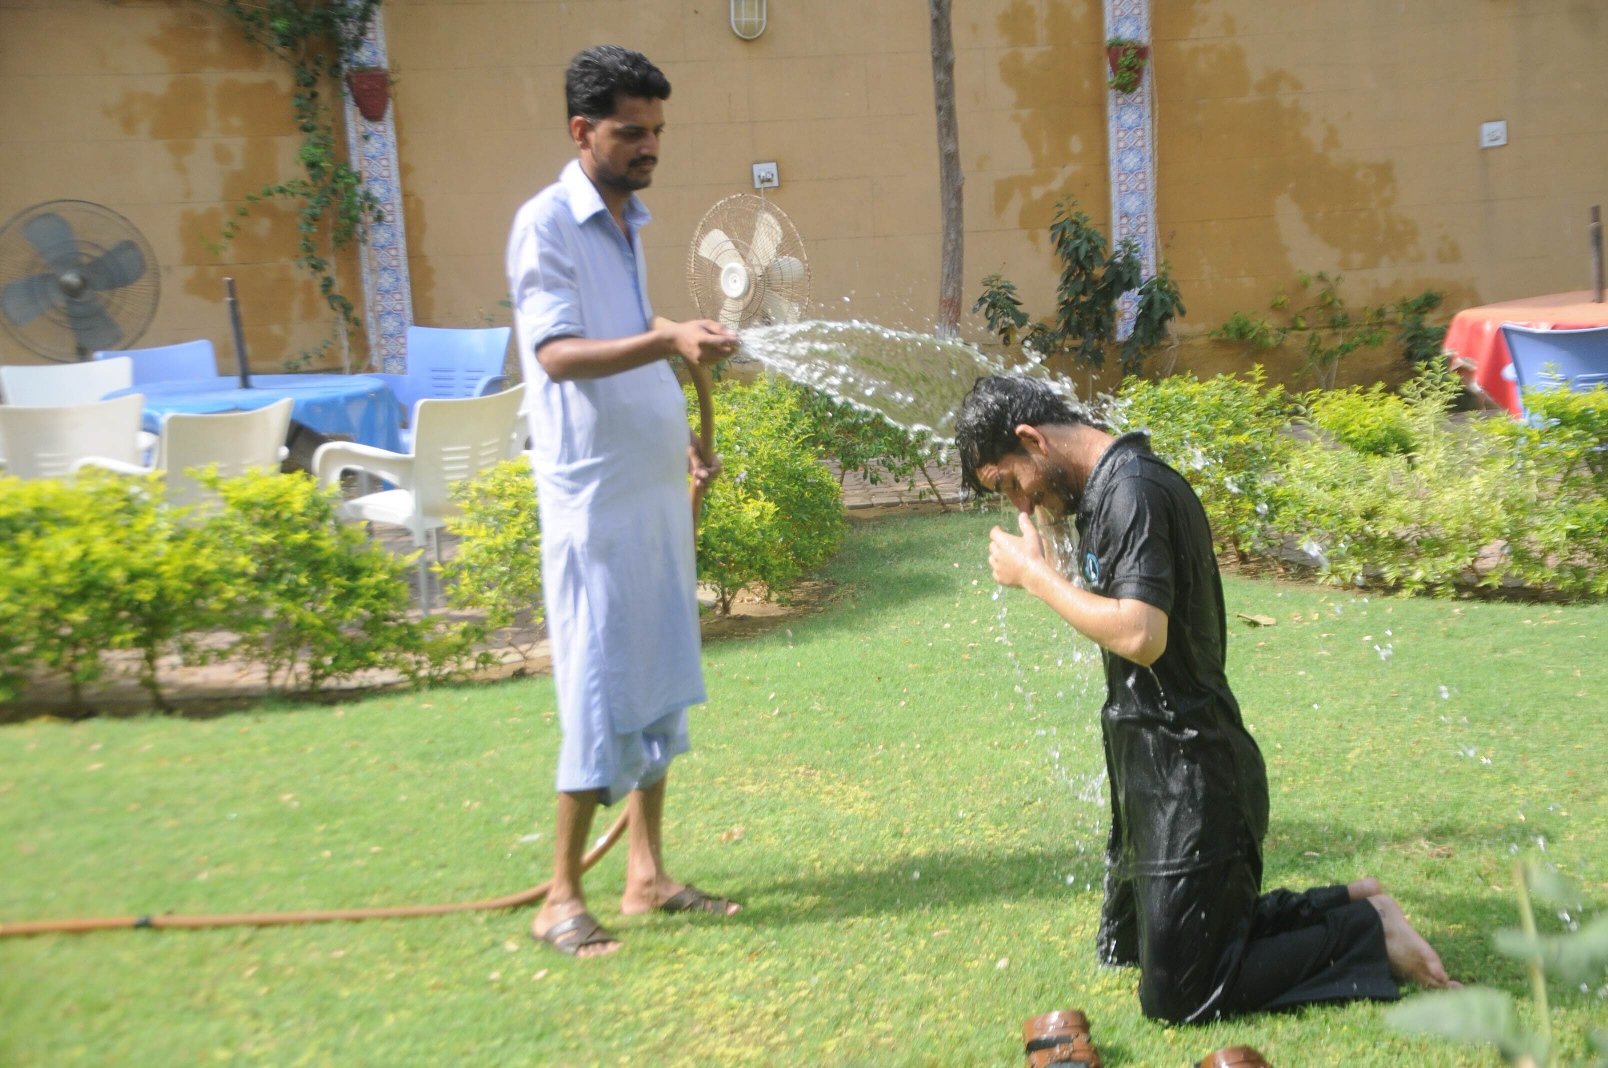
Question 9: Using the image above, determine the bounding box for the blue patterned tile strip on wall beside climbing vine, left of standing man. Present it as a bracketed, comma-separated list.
[344, 11, 413, 373]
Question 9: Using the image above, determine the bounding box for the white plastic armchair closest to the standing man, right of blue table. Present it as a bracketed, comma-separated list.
[312, 384, 524, 613]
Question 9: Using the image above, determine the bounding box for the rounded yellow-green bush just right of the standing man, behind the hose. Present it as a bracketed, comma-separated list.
[687, 376, 844, 613]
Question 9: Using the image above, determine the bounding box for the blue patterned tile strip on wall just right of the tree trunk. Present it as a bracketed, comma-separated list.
[1101, 0, 1156, 339]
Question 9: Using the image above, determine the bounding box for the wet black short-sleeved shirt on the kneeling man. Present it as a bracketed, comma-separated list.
[1077, 433, 1267, 877]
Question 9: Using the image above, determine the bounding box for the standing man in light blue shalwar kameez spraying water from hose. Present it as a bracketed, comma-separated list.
[508, 45, 738, 957]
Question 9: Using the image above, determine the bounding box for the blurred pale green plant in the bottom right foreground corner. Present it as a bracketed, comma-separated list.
[1386, 861, 1608, 1068]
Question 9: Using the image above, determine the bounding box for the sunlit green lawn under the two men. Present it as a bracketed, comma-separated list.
[0, 513, 1608, 1068]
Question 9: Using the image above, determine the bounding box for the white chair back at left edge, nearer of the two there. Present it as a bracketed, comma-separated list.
[0, 392, 145, 478]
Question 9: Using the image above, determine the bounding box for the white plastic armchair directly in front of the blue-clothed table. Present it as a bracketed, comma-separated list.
[77, 397, 296, 505]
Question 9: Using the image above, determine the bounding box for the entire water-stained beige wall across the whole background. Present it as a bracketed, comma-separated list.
[0, 0, 1608, 390]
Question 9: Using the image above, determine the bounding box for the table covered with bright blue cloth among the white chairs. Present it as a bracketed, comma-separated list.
[106, 375, 402, 452]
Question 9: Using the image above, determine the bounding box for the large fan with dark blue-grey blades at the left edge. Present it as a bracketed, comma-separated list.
[0, 199, 159, 362]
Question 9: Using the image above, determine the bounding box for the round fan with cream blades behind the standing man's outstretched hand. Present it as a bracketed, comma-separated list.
[687, 193, 809, 330]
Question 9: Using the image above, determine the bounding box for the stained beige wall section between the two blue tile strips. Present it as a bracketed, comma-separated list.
[386, 0, 1106, 337]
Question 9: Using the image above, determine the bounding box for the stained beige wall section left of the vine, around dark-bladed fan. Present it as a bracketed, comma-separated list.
[0, 0, 365, 370]
